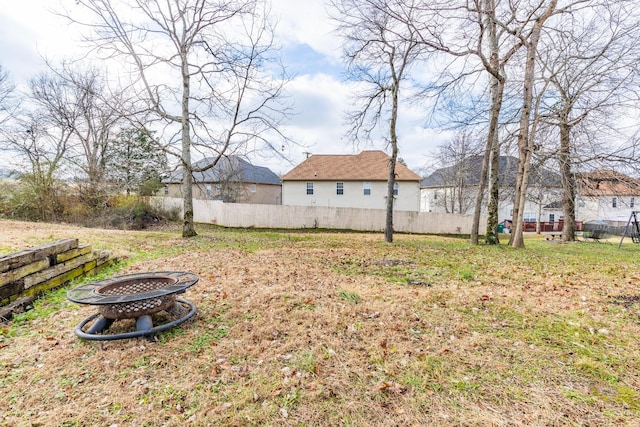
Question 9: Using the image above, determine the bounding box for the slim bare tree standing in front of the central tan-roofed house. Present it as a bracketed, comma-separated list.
[330, 0, 425, 243]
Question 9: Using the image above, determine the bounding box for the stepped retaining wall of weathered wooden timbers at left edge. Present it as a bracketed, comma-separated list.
[0, 239, 117, 321]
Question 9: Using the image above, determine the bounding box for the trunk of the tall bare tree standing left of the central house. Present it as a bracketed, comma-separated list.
[181, 52, 196, 237]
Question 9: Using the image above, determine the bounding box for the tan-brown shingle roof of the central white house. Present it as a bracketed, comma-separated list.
[282, 151, 422, 181]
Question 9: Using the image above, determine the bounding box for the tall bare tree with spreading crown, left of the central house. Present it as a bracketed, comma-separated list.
[66, 0, 287, 237]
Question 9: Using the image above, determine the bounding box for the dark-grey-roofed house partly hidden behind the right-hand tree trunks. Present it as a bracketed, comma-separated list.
[420, 156, 562, 223]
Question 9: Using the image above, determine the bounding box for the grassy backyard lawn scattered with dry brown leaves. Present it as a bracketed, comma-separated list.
[0, 221, 640, 426]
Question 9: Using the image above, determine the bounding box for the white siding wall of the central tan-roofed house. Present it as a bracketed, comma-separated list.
[282, 181, 420, 212]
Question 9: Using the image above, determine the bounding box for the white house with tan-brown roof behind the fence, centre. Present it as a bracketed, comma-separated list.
[282, 151, 421, 211]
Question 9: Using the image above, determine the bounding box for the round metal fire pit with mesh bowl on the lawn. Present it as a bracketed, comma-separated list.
[67, 271, 199, 341]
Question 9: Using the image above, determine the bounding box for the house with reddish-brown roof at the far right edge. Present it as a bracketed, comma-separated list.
[576, 170, 640, 226]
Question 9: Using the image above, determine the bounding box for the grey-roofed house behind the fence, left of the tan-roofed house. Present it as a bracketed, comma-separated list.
[162, 156, 282, 205]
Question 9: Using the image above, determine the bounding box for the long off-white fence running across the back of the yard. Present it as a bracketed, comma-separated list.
[152, 197, 487, 234]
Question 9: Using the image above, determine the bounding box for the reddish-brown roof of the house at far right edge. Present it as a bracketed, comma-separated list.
[576, 170, 640, 196]
